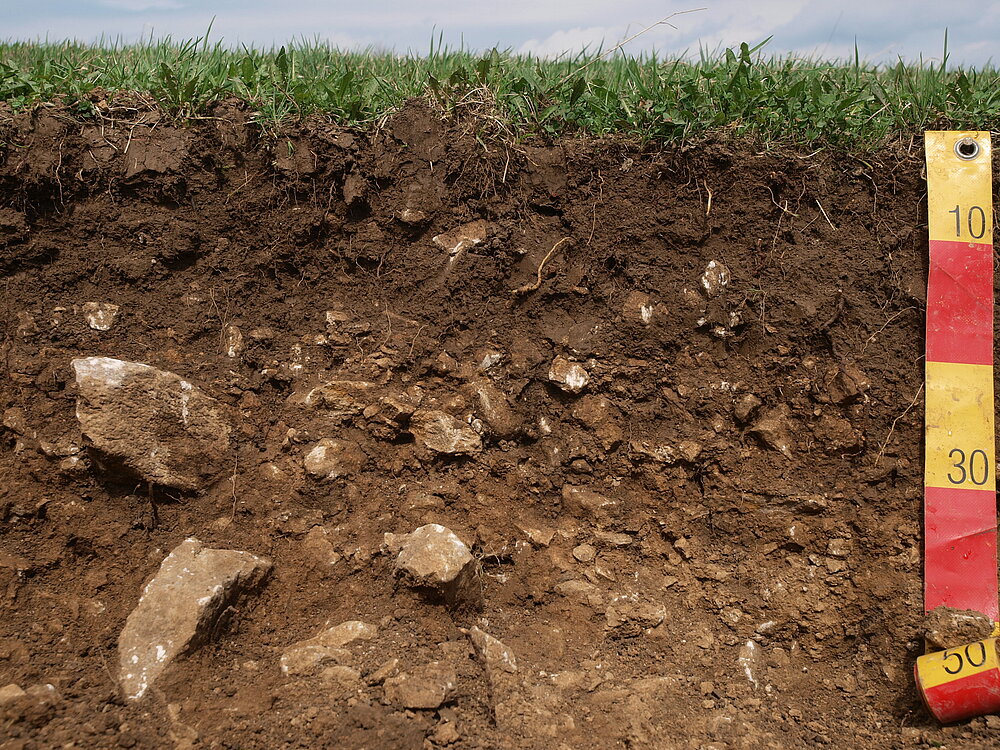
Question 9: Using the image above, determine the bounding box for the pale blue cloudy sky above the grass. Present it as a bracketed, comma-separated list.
[7, 0, 1000, 65]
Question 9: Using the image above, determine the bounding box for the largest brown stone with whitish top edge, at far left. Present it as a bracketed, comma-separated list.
[71, 357, 232, 491]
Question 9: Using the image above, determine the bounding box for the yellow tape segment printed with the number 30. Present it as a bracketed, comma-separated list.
[924, 362, 996, 491]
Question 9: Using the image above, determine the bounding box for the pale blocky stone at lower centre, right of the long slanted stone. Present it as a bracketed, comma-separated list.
[386, 523, 482, 603]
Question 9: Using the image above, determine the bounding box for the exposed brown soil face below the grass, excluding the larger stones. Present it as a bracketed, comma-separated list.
[0, 102, 993, 750]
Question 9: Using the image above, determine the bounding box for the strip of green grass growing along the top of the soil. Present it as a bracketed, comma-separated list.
[0, 37, 1000, 148]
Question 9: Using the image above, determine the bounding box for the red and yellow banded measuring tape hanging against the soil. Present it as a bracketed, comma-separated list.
[916, 131, 1000, 721]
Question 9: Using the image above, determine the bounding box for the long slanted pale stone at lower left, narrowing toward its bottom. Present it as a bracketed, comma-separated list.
[118, 539, 272, 700]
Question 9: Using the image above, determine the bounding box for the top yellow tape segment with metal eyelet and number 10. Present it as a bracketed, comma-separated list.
[924, 130, 993, 244]
